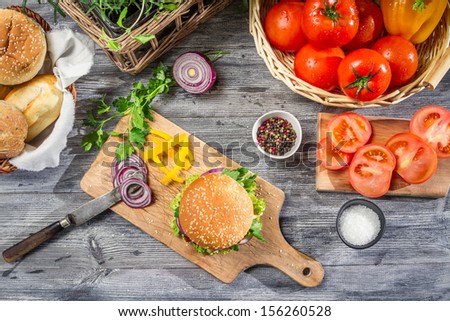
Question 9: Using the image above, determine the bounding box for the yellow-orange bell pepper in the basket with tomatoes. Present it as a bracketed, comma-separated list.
[380, 0, 448, 44]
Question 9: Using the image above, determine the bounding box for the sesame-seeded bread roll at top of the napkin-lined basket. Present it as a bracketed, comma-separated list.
[0, 9, 47, 85]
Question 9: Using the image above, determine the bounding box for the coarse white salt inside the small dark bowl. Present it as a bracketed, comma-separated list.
[339, 205, 381, 246]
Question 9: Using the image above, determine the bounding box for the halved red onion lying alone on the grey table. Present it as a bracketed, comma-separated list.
[172, 51, 216, 94]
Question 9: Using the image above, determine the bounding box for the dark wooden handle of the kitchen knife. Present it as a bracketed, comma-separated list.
[3, 221, 64, 263]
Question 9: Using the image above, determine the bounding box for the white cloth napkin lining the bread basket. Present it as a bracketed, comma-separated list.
[9, 29, 94, 171]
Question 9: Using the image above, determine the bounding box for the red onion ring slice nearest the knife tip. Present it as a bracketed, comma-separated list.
[120, 177, 152, 208]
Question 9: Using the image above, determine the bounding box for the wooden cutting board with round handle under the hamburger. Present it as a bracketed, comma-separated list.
[81, 113, 324, 287]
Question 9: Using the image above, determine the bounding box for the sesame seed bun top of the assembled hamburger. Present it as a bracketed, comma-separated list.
[179, 174, 254, 251]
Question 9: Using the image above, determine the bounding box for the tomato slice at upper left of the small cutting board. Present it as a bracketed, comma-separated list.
[327, 112, 372, 154]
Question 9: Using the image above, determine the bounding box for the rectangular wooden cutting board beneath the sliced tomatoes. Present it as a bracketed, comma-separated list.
[316, 113, 450, 198]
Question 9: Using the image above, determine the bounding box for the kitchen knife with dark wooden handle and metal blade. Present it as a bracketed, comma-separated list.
[3, 187, 122, 263]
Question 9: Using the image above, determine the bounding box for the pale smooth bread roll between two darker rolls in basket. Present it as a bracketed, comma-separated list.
[5, 75, 63, 142]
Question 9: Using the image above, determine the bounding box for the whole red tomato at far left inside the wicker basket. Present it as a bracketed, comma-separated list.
[264, 2, 306, 51]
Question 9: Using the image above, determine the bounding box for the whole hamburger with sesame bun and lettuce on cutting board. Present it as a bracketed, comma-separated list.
[170, 167, 265, 254]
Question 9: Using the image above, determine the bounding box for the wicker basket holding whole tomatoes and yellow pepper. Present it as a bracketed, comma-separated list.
[250, 0, 450, 108]
